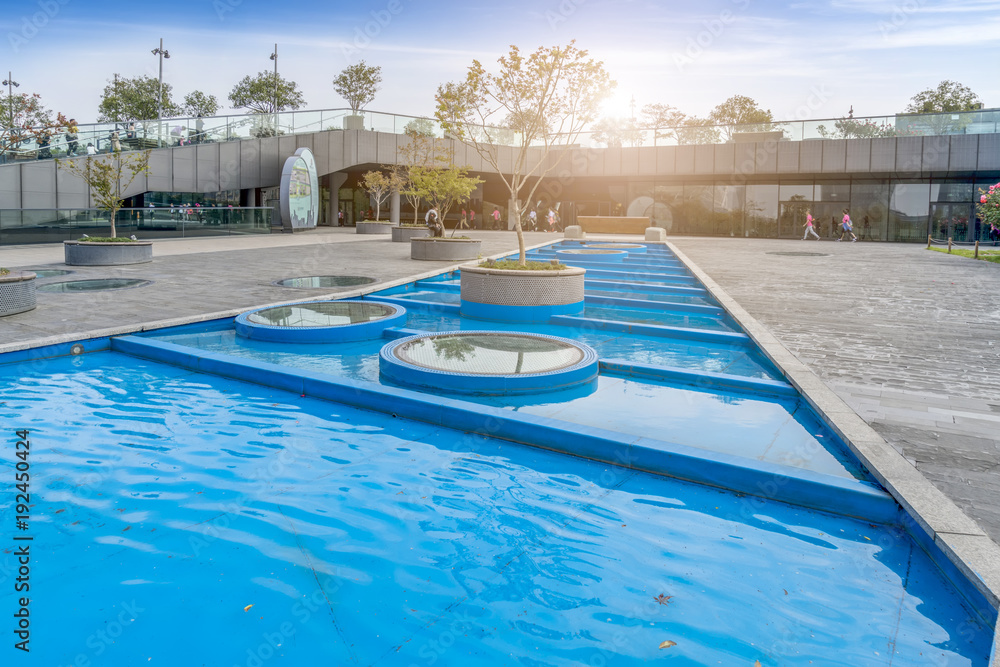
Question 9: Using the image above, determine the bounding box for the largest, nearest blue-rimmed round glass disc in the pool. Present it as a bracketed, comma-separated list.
[379, 331, 598, 394]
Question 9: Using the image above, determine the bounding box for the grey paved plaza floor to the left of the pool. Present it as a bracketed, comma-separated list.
[0, 228, 555, 350]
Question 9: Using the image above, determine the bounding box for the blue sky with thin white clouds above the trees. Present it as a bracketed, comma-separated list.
[0, 0, 1000, 122]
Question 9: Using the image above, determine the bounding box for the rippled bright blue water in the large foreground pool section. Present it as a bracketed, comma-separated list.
[0, 353, 990, 667]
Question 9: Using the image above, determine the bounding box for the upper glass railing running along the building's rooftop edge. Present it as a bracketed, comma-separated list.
[0, 109, 1000, 164]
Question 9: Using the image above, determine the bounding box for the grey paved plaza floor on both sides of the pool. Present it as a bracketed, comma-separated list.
[0, 228, 1000, 542]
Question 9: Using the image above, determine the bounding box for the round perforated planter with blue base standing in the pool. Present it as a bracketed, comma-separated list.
[460, 266, 587, 322]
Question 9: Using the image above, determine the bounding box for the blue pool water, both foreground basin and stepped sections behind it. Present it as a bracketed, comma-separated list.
[0, 239, 996, 667]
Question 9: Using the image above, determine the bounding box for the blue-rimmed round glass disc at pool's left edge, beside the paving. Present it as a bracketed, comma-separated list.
[236, 301, 406, 343]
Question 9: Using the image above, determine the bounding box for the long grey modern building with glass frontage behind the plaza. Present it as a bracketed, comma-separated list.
[0, 110, 1000, 242]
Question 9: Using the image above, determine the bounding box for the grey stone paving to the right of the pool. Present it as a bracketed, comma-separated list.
[670, 237, 1000, 541]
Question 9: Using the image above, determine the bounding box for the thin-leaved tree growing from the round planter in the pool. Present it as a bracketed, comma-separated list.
[435, 41, 616, 266]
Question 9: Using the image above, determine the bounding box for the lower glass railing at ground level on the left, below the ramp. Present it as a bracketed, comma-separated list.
[0, 206, 274, 245]
